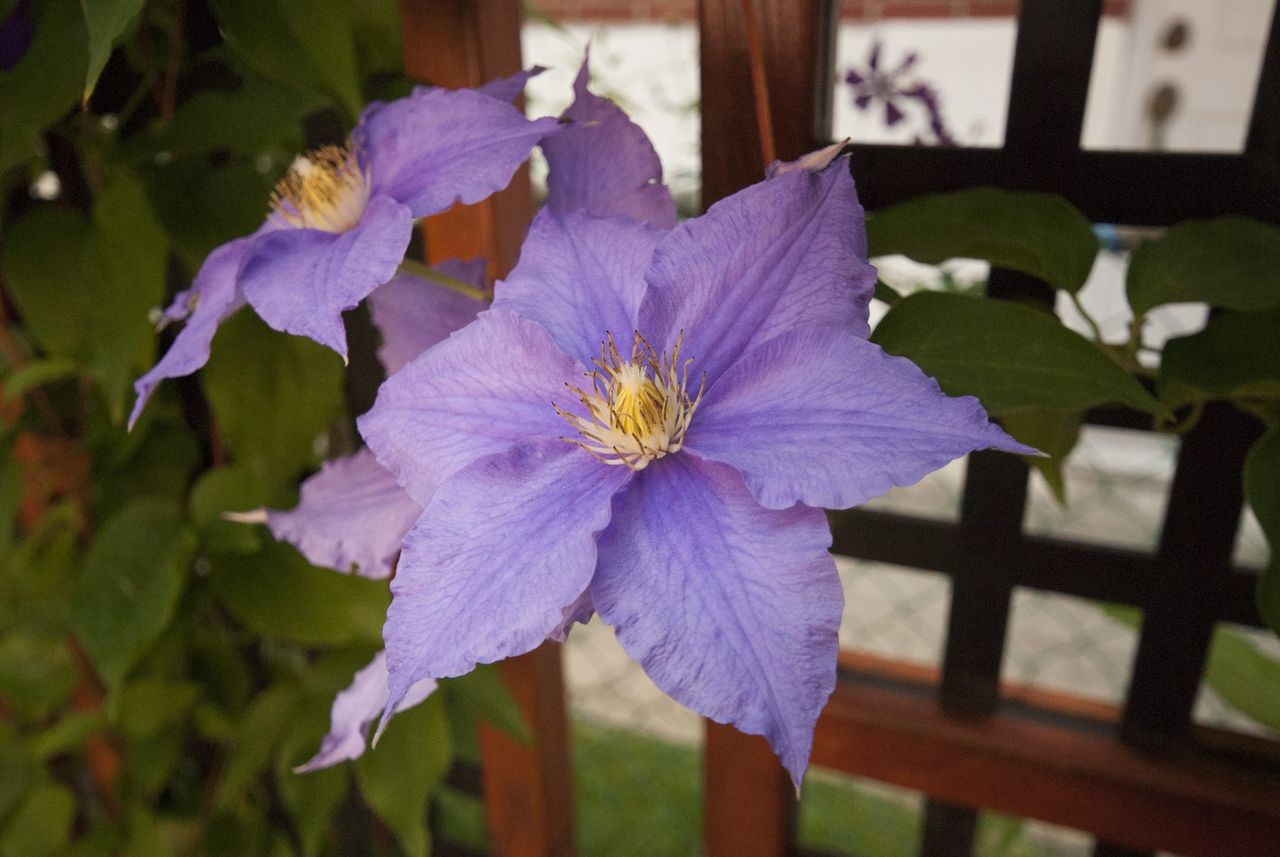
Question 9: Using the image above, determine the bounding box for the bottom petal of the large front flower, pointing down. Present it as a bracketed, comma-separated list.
[591, 454, 844, 784]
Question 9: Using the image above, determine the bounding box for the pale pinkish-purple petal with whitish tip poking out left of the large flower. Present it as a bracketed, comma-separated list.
[266, 449, 422, 578]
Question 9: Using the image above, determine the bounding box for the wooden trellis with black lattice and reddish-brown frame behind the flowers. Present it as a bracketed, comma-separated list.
[401, 0, 1280, 857]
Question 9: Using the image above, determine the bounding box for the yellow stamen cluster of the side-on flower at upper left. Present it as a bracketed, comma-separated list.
[271, 143, 369, 233]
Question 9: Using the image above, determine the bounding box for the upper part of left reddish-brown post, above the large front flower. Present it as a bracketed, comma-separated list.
[401, 0, 532, 276]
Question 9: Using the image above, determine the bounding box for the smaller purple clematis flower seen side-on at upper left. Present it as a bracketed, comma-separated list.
[129, 72, 558, 426]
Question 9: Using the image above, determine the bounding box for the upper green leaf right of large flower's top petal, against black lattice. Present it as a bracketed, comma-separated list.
[867, 188, 1098, 292]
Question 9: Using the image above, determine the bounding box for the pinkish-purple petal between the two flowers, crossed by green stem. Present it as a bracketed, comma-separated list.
[369, 258, 485, 375]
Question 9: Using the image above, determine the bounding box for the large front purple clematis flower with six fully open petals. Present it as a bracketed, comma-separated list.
[360, 151, 1030, 783]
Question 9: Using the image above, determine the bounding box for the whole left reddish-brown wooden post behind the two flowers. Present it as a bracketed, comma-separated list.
[401, 0, 575, 857]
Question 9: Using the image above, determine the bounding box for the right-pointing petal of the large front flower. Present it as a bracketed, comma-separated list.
[685, 327, 1036, 509]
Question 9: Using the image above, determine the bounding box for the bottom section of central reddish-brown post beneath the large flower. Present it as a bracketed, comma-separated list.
[703, 720, 796, 857]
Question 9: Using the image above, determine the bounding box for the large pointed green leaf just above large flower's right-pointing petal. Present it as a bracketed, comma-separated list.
[872, 292, 1167, 416]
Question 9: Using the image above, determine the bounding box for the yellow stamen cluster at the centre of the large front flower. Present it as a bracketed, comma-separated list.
[553, 333, 705, 471]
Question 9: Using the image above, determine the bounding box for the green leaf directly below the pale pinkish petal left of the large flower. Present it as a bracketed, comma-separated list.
[209, 542, 390, 646]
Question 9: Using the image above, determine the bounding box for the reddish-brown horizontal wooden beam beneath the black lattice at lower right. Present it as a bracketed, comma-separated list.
[813, 654, 1280, 857]
